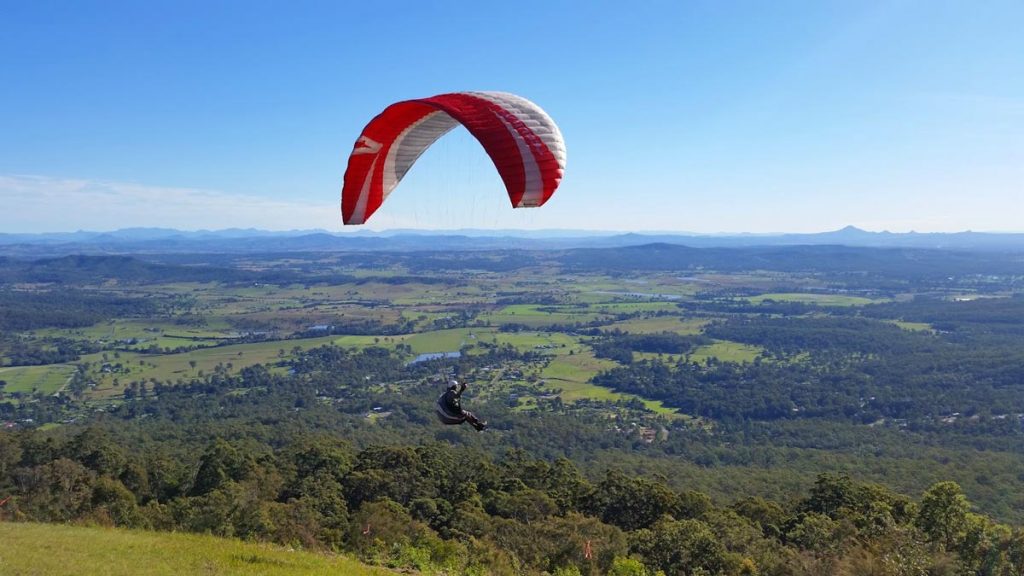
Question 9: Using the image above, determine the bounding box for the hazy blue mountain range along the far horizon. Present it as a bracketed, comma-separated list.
[0, 227, 1024, 253]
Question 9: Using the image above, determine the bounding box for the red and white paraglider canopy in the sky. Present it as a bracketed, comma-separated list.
[341, 92, 565, 224]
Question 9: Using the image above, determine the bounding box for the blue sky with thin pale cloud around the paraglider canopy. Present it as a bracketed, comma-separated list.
[0, 0, 1024, 233]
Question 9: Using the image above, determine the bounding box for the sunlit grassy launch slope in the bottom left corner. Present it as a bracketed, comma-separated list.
[0, 523, 394, 576]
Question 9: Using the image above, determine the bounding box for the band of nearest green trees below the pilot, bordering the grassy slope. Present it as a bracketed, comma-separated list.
[0, 427, 1024, 576]
